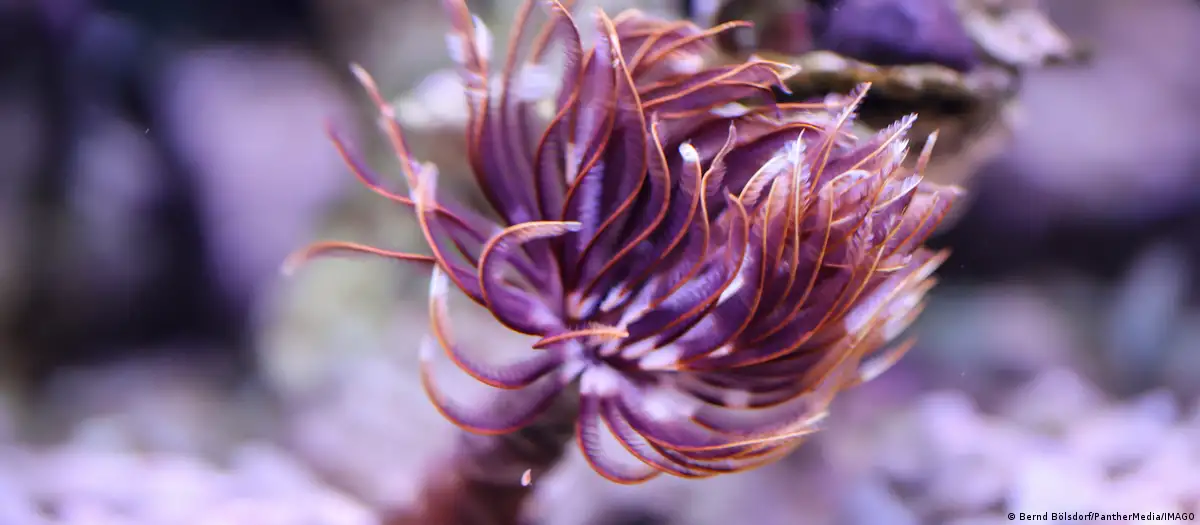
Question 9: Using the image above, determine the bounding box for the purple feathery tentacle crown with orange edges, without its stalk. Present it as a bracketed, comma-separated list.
[290, 0, 959, 483]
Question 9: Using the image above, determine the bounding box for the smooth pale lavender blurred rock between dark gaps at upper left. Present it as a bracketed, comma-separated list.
[163, 43, 352, 333]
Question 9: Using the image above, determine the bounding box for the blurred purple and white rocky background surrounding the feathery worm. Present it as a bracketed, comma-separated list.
[0, 0, 1200, 525]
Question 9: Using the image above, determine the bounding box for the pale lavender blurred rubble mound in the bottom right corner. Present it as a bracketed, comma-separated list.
[829, 370, 1200, 523]
